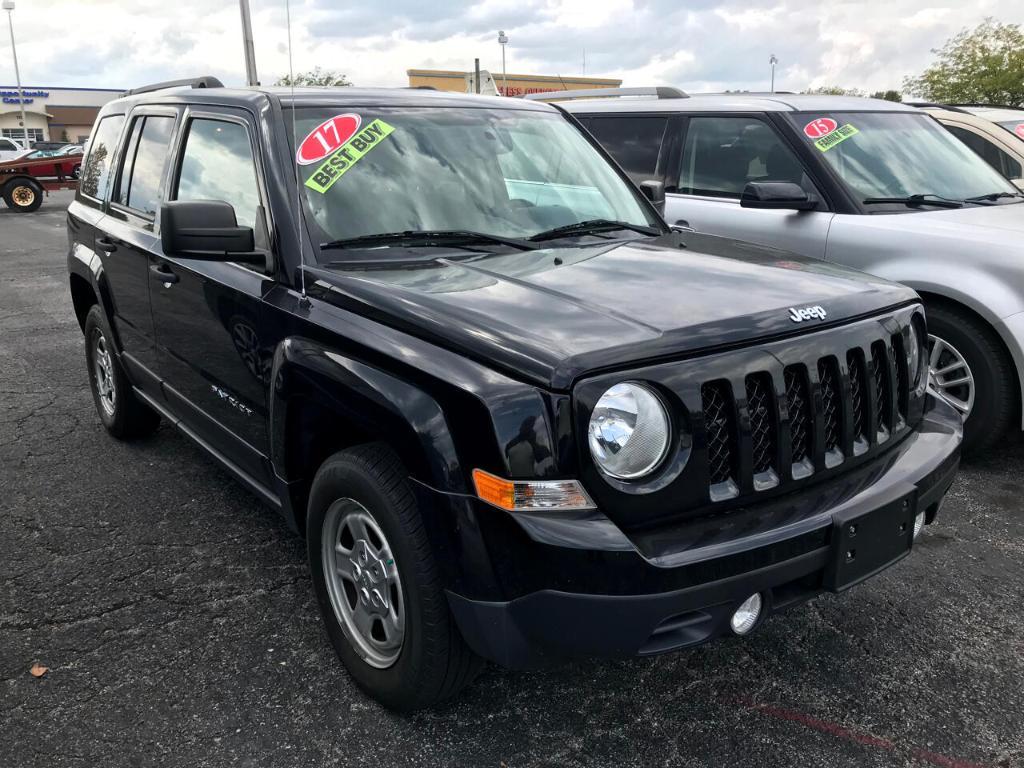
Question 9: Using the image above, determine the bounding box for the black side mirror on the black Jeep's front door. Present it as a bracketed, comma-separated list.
[160, 200, 266, 264]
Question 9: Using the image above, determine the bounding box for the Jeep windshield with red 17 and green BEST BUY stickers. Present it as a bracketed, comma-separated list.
[286, 106, 660, 259]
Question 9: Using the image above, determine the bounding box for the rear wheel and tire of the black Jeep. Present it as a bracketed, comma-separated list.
[85, 304, 160, 440]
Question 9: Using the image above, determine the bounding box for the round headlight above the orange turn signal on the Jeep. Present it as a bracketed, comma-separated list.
[588, 382, 671, 480]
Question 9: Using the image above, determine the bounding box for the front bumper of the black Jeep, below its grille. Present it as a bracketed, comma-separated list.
[449, 398, 963, 669]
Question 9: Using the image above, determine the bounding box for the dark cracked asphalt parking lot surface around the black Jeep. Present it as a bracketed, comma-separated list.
[0, 194, 1024, 768]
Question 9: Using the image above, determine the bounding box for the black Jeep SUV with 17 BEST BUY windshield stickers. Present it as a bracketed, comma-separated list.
[68, 81, 962, 709]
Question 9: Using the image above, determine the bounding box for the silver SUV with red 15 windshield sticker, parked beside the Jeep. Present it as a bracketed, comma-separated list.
[545, 88, 1024, 452]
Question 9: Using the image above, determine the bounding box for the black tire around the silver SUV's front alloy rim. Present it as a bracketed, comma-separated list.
[926, 304, 1017, 457]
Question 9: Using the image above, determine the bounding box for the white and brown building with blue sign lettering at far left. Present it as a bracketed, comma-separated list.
[0, 85, 124, 143]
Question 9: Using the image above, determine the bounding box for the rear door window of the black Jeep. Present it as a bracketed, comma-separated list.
[117, 115, 174, 216]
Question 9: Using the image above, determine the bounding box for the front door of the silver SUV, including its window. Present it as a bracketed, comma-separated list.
[665, 114, 834, 259]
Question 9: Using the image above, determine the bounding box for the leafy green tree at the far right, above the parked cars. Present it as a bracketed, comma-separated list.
[903, 18, 1024, 106]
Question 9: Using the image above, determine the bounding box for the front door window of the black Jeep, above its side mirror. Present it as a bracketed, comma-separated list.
[176, 118, 259, 226]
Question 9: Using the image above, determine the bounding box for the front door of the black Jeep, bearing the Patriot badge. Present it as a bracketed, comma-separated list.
[151, 108, 272, 484]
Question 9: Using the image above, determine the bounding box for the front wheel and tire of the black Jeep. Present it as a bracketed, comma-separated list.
[306, 443, 483, 712]
